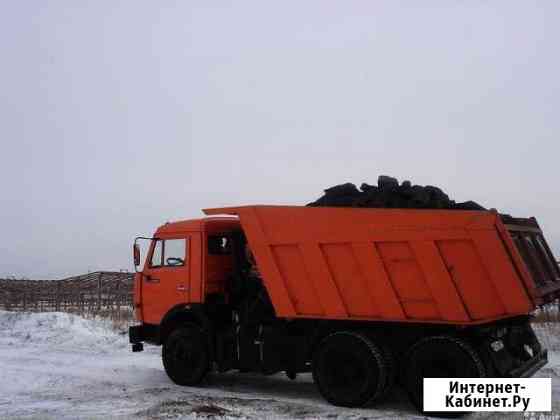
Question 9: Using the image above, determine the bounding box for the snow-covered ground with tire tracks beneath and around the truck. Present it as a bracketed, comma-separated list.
[0, 311, 560, 419]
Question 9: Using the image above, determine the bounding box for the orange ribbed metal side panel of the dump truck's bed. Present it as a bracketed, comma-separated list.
[205, 206, 534, 324]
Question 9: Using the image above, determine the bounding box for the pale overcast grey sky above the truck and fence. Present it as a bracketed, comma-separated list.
[0, 0, 560, 278]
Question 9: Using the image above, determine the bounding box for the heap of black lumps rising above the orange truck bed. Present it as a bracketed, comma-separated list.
[308, 175, 486, 210]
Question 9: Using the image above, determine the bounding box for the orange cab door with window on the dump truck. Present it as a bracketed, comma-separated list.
[142, 236, 191, 325]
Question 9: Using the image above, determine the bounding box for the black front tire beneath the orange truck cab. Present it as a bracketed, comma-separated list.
[161, 325, 210, 386]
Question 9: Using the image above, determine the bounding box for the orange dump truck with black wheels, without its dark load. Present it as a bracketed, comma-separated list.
[129, 205, 560, 410]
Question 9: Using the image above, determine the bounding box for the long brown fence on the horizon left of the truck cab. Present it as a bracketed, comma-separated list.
[0, 271, 134, 319]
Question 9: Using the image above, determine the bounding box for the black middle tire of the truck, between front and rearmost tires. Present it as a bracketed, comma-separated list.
[313, 331, 387, 407]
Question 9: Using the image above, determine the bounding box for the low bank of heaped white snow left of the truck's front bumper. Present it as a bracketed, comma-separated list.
[0, 311, 128, 352]
